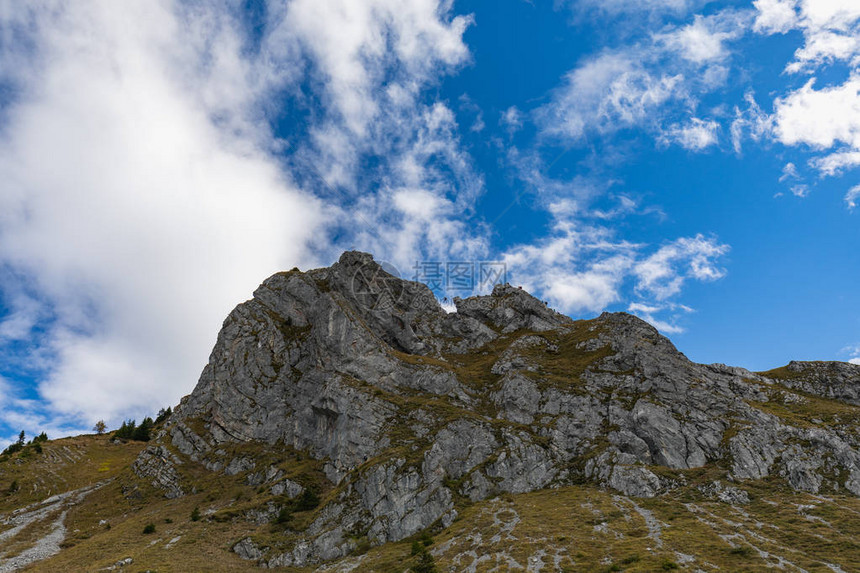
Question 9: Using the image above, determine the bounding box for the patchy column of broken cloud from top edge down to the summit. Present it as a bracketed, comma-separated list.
[278, 0, 487, 274]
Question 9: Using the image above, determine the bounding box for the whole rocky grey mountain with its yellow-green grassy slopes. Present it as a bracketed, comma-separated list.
[0, 252, 860, 572]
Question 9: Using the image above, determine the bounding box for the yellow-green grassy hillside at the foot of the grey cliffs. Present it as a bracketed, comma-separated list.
[0, 436, 860, 573]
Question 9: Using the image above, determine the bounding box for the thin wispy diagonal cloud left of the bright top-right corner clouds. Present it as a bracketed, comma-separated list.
[536, 10, 751, 144]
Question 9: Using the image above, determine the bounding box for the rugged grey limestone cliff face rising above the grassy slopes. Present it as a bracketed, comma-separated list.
[135, 252, 860, 566]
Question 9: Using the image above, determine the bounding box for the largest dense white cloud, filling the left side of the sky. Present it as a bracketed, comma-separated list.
[0, 2, 324, 427]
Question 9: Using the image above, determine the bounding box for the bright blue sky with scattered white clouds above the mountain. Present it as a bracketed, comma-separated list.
[0, 0, 860, 440]
